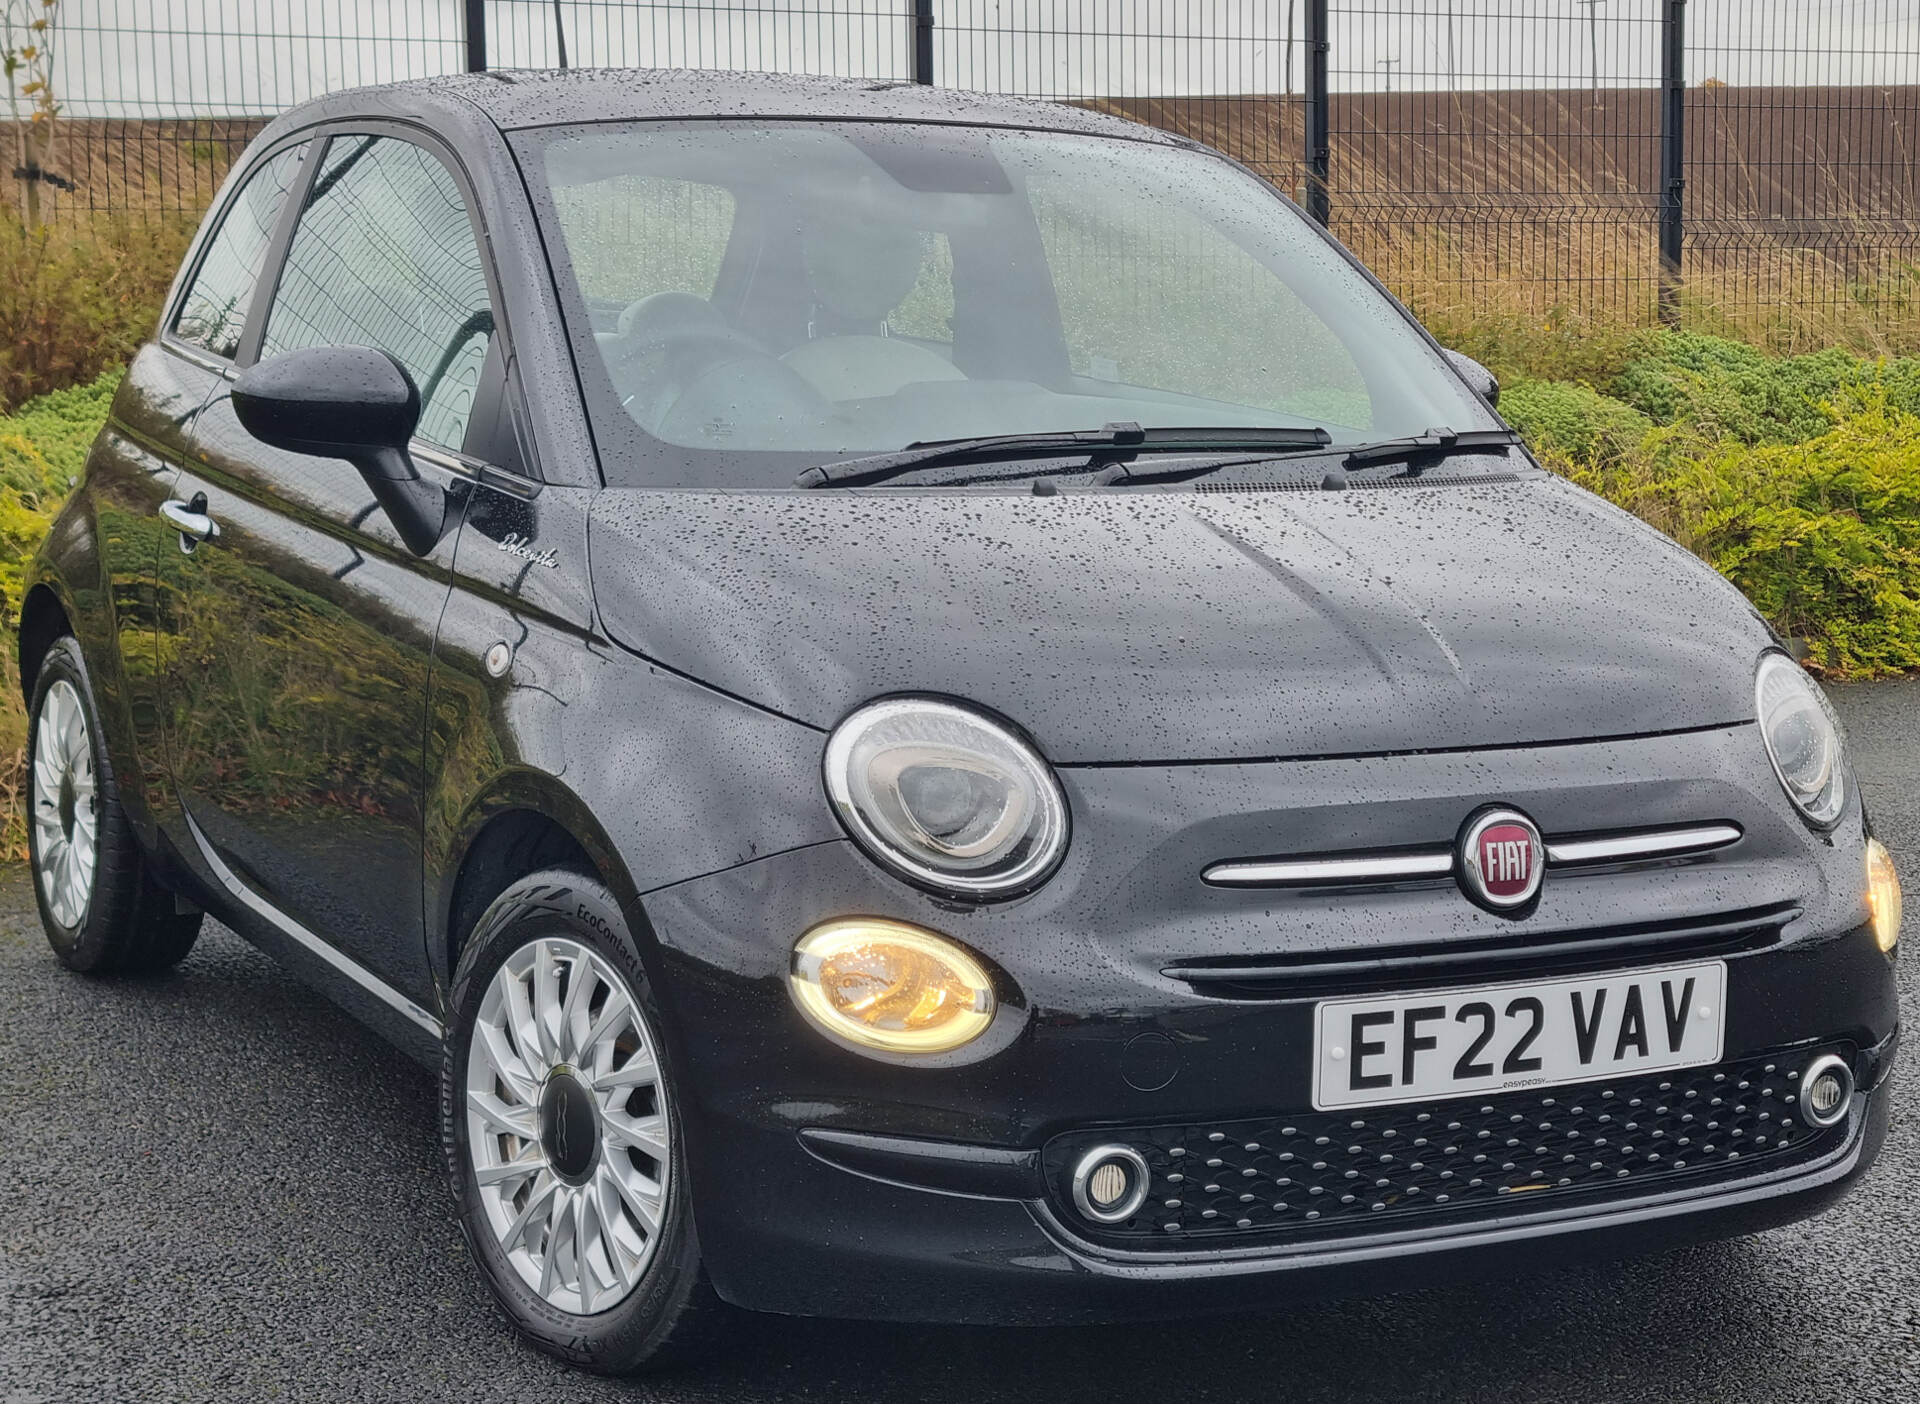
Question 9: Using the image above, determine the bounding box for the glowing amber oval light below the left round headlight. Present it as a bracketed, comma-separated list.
[787, 916, 993, 1053]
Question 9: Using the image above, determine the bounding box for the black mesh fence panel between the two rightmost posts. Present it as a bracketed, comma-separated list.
[1329, 0, 1663, 319]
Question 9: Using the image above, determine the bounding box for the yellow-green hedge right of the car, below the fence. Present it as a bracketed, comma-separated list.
[1501, 332, 1920, 676]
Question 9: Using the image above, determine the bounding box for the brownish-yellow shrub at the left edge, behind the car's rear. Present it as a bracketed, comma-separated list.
[0, 207, 192, 413]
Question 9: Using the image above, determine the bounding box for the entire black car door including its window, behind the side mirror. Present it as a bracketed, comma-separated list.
[161, 133, 497, 1016]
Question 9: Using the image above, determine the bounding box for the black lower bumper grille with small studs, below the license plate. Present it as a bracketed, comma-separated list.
[1044, 1047, 1853, 1248]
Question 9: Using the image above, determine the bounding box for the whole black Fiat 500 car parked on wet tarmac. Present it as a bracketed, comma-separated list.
[19, 71, 1899, 1371]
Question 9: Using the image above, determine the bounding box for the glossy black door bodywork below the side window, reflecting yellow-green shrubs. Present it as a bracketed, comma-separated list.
[159, 386, 456, 999]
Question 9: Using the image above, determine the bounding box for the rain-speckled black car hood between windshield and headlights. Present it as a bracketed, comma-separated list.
[589, 472, 1768, 764]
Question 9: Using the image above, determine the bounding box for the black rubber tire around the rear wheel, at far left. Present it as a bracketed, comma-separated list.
[27, 636, 200, 976]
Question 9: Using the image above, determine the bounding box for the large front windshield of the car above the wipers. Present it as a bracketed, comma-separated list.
[515, 121, 1498, 486]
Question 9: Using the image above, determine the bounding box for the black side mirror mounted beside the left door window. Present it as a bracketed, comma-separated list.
[232, 346, 447, 555]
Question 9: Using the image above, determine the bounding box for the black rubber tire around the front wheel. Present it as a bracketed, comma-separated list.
[440, 868, 730, 1375]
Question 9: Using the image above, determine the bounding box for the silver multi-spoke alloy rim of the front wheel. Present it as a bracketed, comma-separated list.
[467, 937, 670, 1316]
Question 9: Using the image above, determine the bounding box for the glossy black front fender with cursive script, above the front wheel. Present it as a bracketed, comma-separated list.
[426, 472, 839, 998]
